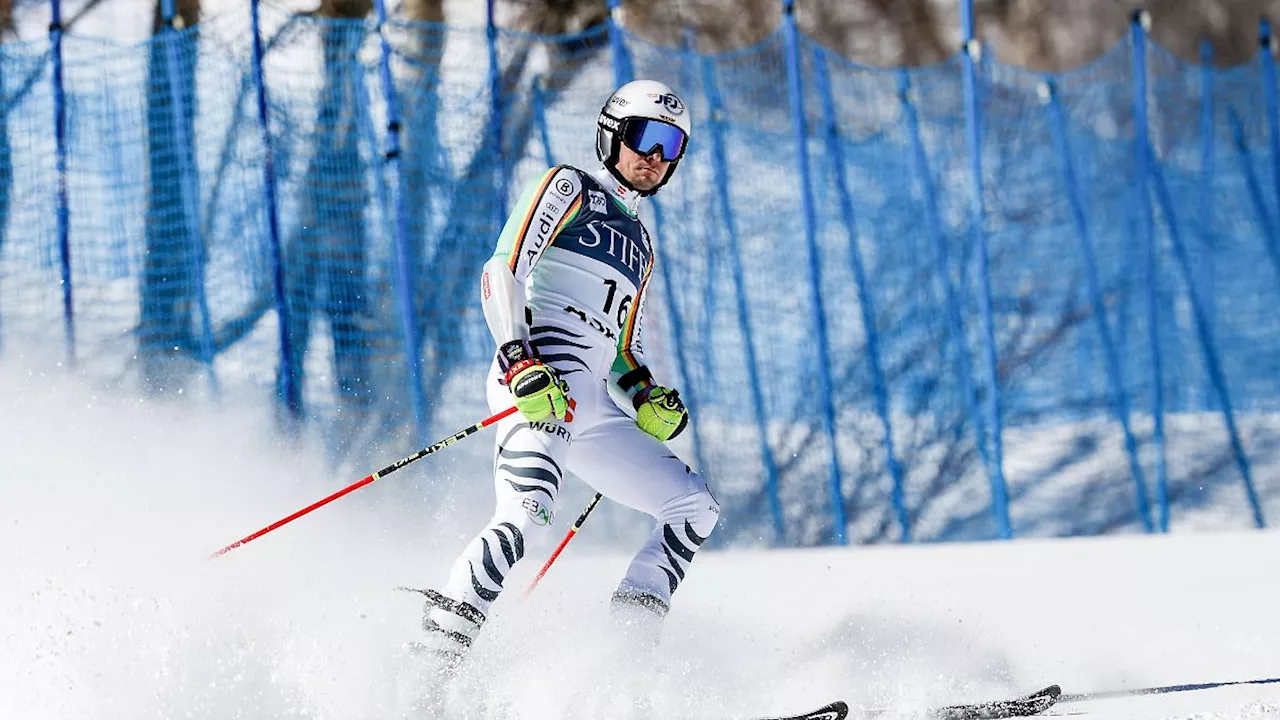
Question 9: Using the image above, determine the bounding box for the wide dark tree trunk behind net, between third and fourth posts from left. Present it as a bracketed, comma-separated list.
[284, 0, 372, 420]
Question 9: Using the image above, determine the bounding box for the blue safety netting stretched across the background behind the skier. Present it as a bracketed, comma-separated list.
[0, 4, 1280, 544]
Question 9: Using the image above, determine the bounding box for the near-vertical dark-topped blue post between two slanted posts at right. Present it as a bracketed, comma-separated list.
[1129, 10, 1169, 528]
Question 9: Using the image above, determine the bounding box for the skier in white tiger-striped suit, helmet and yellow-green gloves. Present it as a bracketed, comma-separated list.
[421, 81, 719, 666]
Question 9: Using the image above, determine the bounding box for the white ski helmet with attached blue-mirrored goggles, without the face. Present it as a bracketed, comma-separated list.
[595, 79, 692, 195]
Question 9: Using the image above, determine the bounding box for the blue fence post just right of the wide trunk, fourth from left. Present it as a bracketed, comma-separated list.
[374, 0, 428, 438]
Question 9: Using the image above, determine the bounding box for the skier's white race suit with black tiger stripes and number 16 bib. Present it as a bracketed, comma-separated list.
[428, 165, 719, 628]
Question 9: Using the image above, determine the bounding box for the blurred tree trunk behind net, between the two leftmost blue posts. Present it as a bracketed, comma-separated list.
[137, 0, 205, 392]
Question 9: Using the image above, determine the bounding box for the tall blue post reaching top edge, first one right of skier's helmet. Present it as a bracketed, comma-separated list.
[782, 0, 849, 544]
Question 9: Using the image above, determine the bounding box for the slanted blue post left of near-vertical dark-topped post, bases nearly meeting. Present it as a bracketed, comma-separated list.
[1042, 77, 1169, 533]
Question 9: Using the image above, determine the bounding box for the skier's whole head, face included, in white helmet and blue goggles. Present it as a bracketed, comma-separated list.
[595, 79, 690, 195]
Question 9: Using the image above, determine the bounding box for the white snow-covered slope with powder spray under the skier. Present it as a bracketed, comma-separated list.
[0, 361, 1280, 720]
